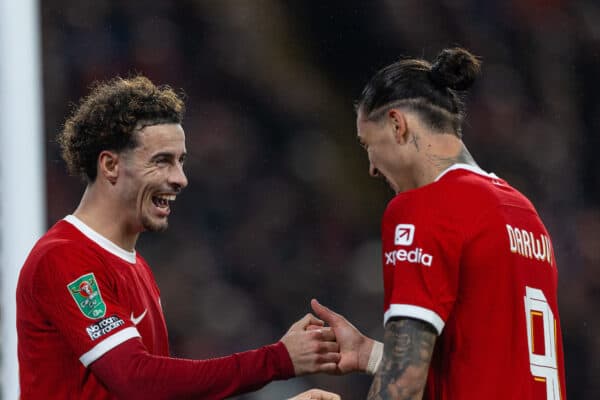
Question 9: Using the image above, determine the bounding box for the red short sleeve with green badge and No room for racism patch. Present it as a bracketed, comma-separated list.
[32, 242, 140, 367]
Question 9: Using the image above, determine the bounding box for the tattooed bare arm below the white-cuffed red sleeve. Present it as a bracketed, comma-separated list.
[368, 318, 437, 400]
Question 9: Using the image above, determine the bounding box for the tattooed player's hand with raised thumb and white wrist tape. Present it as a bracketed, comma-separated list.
[310, 299, 375, 374]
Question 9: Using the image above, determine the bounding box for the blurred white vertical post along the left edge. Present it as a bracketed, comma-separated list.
[0, 0, 46, 400]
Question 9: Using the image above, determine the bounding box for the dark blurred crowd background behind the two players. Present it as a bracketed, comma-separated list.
[31, 0, 600, 400]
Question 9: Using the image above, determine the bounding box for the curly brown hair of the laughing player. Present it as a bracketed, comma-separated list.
[57, 75, 185, 182]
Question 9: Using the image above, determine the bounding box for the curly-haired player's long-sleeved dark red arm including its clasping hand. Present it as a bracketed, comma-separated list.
[90, 314, 339, 399]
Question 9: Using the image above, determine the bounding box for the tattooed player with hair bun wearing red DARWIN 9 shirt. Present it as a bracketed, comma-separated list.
[313, 48, 566, 400]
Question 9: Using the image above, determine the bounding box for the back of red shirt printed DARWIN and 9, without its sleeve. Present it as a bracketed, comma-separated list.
[429, 169, 565, 400]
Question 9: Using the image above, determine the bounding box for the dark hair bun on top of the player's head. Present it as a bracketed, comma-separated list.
[429, 47, 481, 90]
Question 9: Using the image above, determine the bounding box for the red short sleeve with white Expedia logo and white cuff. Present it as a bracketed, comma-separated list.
[382, 196, 462, 334]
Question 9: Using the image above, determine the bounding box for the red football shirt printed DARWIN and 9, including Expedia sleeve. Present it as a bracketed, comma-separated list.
[382, 164, 566, 400]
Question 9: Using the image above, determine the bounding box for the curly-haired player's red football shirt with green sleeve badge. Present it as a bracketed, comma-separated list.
[17, 216, 169, 399]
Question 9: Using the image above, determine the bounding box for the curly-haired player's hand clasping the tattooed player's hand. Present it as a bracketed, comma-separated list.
[281, 314, 340, 376]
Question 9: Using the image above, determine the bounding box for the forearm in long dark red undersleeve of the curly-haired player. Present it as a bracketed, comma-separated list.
[90, 340, 294, 399]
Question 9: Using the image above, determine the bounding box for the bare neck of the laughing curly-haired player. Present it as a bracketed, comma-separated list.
[73, 184, 139, 251]
